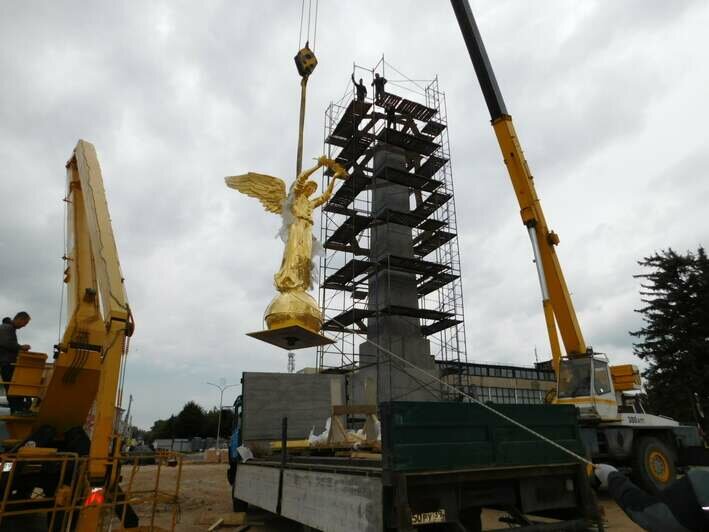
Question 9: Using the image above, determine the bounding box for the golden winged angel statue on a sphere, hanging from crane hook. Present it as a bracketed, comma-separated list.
[225, 156, 348, 342]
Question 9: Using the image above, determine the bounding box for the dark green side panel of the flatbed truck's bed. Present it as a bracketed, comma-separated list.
[381, 401, 586, 472]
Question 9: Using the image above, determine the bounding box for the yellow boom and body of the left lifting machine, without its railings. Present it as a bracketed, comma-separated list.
[0, 140, 153, 532]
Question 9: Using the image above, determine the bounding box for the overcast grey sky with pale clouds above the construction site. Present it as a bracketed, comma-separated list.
[0, 0, 709, 427]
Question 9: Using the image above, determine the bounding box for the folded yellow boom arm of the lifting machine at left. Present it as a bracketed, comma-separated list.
[57, 140, 133, 478]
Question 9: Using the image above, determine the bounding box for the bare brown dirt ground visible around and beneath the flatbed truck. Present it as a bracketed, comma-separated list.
[124, 462, 642, 532]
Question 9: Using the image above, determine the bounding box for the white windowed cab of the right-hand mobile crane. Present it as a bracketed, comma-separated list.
[556, 354, 619, 421]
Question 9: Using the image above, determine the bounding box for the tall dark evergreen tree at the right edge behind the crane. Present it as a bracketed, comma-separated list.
[630, 247, 709, 421]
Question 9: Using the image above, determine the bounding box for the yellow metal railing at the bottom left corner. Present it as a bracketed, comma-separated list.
[0, 448, 182, 531]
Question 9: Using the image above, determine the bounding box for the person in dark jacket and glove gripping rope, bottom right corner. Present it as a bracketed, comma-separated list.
[594, 464, 709, 532]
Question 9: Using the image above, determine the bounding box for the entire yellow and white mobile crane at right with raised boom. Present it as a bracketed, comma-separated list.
[451, 0, 707, 489]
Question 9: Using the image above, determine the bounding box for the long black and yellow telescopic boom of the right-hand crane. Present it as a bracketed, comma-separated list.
[451, 0, 587, 369]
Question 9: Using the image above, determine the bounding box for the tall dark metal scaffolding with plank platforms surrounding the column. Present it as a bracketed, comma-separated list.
[317, 58, 468, 396]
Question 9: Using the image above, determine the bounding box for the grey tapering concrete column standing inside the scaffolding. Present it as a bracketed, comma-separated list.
[353, 145, 438, 402]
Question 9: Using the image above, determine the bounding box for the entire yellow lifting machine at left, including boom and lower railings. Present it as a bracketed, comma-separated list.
[0, 140, 177, 532]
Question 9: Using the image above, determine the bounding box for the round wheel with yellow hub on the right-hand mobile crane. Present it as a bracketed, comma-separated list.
[633, 436, 677, 494]
